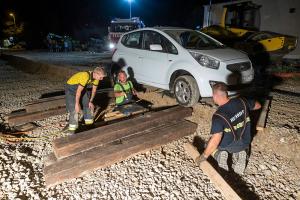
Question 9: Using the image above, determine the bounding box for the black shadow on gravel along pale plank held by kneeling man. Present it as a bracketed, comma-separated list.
[193, 136, 259, 200]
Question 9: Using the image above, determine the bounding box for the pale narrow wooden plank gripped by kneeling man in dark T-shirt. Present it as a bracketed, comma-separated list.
[184, 143, 241, 200]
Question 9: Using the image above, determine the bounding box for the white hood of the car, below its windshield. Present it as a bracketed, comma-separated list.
[192, 48, 248, 61]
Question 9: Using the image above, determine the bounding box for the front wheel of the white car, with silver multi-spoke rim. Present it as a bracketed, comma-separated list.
[173, 75, 200, 107]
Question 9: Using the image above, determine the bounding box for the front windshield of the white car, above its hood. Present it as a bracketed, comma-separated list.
[164, 30, 224, 50]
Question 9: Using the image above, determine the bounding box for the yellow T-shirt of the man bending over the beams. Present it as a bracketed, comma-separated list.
[67, 71, 99, 87]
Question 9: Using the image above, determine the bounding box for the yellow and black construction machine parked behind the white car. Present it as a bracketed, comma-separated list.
[201, 1, 297, 57]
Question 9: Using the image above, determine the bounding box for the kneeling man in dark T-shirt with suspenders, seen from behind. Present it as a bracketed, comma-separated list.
[200, 83, 261, 174]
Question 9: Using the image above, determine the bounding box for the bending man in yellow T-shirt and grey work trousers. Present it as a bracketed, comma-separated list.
[65, 67, 106, 132]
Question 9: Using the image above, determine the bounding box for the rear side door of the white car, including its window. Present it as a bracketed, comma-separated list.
[120, 31, 143, 82]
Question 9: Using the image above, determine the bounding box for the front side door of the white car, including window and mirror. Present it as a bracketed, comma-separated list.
[139, 30, 175, 87]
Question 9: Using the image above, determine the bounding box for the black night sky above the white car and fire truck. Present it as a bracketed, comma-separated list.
[0, 0, 225, 45]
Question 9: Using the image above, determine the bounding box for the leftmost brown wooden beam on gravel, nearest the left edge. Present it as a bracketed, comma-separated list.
[7, 108, 66, 126]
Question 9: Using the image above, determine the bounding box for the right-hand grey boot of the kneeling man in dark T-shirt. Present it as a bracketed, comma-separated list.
[232, 150, 247, 175]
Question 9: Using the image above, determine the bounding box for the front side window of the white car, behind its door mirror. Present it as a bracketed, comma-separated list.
[143, 31, 178, 54]
